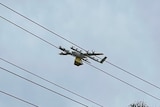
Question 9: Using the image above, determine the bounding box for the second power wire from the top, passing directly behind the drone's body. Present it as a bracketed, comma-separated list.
[0, 16, 160, 100]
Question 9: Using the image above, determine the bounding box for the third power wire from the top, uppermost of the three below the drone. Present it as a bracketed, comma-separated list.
[0, 58, 103, 107]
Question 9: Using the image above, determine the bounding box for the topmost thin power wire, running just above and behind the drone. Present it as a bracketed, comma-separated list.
[0, 3, 160, 89]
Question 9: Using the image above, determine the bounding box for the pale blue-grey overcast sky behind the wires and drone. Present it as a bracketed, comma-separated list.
[0, 0, 160, 107]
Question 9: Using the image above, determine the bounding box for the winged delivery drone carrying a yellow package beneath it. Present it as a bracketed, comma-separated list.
[59, 46, 107, 66]
